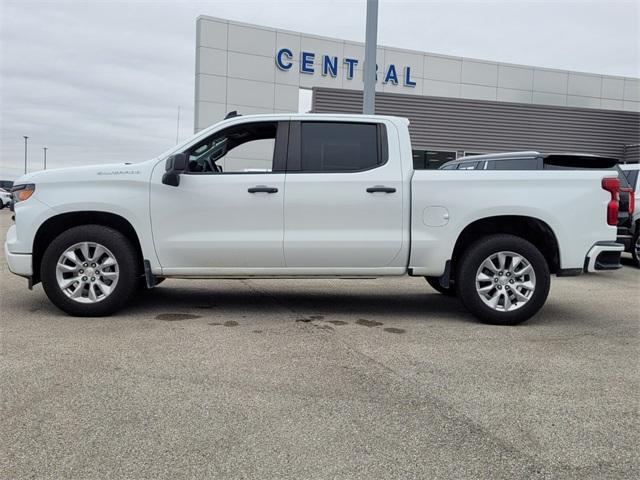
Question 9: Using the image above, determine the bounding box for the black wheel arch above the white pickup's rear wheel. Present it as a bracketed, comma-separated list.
[451, 215, 560, 273]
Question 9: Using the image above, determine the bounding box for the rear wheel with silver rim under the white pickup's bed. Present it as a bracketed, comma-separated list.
[456, 234, 551, 325]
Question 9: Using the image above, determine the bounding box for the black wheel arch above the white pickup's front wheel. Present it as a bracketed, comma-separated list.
[32, 211, 144, 285]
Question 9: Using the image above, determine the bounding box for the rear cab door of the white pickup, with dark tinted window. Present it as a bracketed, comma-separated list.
[284, 121, 403, 273]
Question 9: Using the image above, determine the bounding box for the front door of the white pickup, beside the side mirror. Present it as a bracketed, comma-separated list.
[150, 121, 288, 275]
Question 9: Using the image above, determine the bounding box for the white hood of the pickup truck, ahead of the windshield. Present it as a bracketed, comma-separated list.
[14, 158, 158, 185]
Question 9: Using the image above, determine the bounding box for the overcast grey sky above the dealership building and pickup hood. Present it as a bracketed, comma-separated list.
[0, 0, 640, 179]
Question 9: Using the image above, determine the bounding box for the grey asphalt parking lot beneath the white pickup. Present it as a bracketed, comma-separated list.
[0, 211, 640, 479]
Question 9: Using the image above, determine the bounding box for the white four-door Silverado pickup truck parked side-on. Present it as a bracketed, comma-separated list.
[5, 114, 623, 325]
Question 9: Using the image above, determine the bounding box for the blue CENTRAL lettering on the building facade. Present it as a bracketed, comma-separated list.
[275, 48, 416, 87]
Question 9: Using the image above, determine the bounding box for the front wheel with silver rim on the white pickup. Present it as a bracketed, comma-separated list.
[40, 225, 140, 317]
